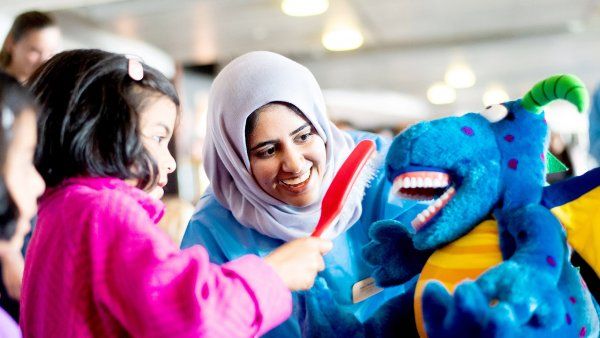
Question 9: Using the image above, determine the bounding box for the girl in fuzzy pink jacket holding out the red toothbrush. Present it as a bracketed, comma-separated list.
[21, 50, 331, 337]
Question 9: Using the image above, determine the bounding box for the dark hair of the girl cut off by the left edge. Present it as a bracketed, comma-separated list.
[0, 71, 36, 240]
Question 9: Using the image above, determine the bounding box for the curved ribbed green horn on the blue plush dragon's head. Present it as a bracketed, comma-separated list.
[521, 74, 590, 114]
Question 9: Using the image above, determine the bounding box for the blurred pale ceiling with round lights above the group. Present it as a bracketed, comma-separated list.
[3, 0, 600, 119]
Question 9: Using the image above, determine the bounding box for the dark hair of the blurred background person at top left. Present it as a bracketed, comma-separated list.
[0, 11, 56, 68]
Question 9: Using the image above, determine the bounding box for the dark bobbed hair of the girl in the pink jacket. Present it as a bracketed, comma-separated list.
[30, 49, 179, 189]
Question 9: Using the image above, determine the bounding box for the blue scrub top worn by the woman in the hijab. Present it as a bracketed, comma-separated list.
[181, 132, 422, 337]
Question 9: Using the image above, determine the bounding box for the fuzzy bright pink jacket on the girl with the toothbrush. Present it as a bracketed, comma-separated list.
[21, 178, 292, 337]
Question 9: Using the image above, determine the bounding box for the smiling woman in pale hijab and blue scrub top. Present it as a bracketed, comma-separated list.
[182, 52, 414, 337]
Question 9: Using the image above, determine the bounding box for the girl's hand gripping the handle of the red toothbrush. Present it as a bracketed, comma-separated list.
[265, 237, 333, 291]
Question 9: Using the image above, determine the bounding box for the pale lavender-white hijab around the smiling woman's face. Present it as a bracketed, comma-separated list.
[200, 51, 362, 241]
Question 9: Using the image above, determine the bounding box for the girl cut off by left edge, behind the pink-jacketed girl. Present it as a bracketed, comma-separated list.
[0, 72, 44, 337]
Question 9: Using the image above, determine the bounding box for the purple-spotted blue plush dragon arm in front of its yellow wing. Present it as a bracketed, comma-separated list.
[477, 205, 567, 328]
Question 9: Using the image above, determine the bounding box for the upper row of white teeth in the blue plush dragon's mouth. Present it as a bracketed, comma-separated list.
[392, 171, 450, 200]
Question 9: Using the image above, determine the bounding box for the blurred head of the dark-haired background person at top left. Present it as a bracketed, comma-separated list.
[0, 11, 61, 83]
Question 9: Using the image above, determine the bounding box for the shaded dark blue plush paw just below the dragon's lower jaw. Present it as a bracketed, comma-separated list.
[363, 220, 431, 287]
